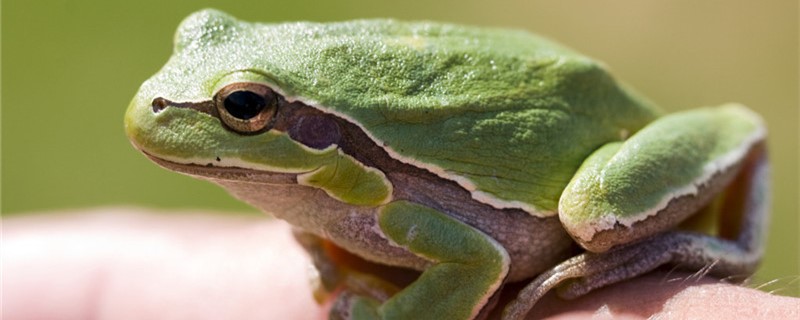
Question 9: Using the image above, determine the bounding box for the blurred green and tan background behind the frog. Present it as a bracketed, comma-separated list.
[0, 0, 800, 296]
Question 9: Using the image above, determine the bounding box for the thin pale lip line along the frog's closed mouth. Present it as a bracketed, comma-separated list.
[142, 151, 297, 184]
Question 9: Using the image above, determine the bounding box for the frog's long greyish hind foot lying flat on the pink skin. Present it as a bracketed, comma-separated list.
[503, 232, 760, 319]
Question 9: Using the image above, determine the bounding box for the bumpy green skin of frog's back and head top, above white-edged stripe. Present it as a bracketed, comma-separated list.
[130, 10, 656, 215]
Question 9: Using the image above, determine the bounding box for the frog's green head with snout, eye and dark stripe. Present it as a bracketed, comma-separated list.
[125, 10, 391, 205]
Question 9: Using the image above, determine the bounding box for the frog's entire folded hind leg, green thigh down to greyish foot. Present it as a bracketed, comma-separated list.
[504, 106, 769, 319]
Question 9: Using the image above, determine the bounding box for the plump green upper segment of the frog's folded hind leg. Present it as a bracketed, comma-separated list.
[559, 105, 766, 252]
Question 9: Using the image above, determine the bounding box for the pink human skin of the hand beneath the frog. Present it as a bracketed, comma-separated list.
[2, 209, 800, 319]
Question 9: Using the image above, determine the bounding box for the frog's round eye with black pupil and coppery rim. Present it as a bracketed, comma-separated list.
[214, 82, 278, 133]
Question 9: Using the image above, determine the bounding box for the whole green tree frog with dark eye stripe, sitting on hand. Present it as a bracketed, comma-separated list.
[125, 9, 769, 319]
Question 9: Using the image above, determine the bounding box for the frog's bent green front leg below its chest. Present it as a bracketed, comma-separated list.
[333, 201, 510, 319]
